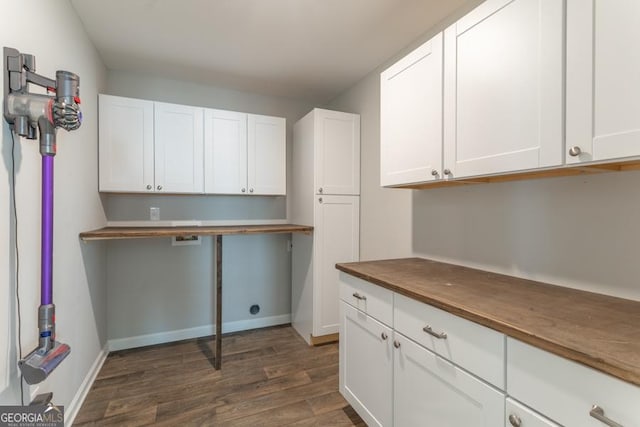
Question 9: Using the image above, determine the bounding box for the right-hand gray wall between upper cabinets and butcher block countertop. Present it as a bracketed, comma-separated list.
[329, 2, 640, 300]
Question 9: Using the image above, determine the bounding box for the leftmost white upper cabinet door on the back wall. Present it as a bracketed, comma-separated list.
[99, 95, 154, 192]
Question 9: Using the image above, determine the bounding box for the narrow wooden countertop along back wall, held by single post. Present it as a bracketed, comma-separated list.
[80, 224, 313, 241]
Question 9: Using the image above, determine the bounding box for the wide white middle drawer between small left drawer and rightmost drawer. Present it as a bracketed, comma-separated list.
[393, 294, 505, 390]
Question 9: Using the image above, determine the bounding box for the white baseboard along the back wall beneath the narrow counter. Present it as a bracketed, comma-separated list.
[108, 314, 291, 351]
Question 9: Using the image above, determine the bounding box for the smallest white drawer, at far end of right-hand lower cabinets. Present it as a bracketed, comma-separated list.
[339, 272, 393, 326]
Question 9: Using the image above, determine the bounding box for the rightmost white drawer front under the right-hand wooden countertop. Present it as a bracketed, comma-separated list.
[507, 338, 640, 427]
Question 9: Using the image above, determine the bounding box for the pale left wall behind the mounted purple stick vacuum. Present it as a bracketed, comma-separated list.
[0, 0, 107, 415]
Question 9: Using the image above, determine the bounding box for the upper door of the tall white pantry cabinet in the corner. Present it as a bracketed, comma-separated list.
[314, 108, 360, 195]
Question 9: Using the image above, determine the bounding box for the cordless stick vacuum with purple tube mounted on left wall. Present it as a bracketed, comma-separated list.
[4, 47, 82, 384]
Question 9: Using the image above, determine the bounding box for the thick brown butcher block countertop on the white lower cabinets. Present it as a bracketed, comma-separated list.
[336, 258, 640, 385]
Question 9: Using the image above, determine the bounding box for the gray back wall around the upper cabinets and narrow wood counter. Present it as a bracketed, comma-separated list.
[102, 71, 313, 347]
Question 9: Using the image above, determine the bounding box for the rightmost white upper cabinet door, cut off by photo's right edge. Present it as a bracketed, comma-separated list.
[566, 0, 640, 164]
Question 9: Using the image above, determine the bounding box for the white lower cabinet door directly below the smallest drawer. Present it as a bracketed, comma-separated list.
[339, 302, 393, 426]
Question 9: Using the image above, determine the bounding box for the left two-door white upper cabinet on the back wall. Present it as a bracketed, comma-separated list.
[99, 94, 204, 193]
